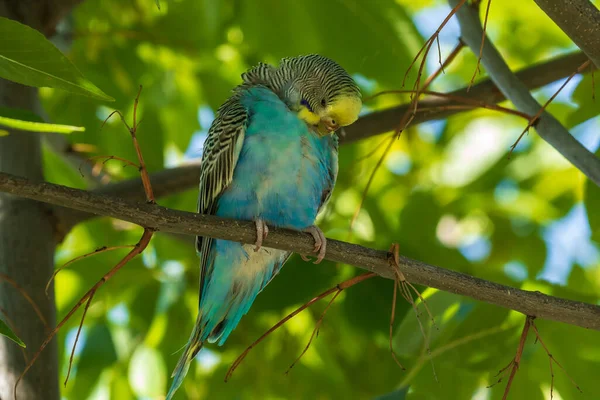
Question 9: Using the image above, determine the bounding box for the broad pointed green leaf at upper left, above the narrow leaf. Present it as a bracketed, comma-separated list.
[0, 17, 114, 101]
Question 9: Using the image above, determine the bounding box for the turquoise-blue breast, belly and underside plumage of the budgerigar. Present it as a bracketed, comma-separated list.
[200, 88, 337, 344]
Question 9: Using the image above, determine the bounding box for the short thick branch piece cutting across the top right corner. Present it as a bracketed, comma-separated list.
[534, 0, 600, 67]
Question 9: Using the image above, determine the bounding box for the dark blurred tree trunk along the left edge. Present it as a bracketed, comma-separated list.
[0, 0, 60, 400]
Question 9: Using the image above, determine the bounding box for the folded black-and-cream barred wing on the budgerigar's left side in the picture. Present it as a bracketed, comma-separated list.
[196, 95, 249, 298]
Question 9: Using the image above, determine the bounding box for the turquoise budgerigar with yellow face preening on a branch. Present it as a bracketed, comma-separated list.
[167, 55, 362, 400]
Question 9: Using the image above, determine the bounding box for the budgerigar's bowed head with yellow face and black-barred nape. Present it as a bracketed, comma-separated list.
[242, 54, 362, 136]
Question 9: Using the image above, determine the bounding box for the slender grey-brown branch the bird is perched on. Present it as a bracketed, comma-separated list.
[0, 173, 600, 331]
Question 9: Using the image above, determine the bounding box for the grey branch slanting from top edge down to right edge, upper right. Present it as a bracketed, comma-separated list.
[449, 0, 600, 186]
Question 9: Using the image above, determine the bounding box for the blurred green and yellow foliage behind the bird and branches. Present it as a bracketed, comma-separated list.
[23, 0, 600, 400]
